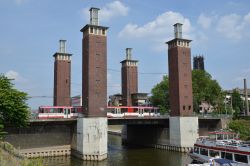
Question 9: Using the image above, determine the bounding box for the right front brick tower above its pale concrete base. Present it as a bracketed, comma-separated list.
[167, 23, 193, 116]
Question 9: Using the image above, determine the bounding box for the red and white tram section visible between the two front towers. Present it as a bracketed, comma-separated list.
[107, 106, 160, 118]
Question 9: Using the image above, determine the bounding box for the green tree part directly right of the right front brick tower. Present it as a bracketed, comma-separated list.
[192, 70, 225, 112]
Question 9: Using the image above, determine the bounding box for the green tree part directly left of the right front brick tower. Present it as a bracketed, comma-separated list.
[150, 76, 170, 113]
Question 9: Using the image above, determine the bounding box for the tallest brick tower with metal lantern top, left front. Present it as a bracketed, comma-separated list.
[81, 8, 108, 117]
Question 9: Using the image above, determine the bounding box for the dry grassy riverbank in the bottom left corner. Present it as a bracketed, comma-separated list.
[0, 142, 43, 166]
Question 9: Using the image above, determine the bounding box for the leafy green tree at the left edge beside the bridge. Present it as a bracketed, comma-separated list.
[0, 75, 29, 127]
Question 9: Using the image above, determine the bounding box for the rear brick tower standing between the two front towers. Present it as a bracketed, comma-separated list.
[121, 48, 138, 106]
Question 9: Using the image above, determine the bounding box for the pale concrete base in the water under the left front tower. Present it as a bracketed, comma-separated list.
[73, 117, 108, 161]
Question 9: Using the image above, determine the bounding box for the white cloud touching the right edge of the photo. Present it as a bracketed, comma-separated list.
[216, 13, 250, 40]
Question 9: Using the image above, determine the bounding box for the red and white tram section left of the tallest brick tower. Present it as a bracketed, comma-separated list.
[38, 106, 82, 119]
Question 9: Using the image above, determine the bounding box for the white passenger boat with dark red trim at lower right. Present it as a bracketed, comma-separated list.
[189, 131, 250, 165]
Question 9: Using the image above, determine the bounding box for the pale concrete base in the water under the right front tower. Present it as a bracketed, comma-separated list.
[169, 116, 199, 149]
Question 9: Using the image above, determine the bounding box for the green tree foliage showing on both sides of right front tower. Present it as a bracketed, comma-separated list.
[151, 70, 224, 112]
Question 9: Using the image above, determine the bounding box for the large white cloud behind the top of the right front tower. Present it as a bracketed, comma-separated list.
[119, 11, 192, 51]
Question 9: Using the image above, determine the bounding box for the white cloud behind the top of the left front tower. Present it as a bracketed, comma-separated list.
[81, 1, 129, 21]
